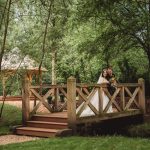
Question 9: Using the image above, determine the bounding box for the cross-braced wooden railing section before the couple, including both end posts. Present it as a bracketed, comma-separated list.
[67, 77, 145, 128]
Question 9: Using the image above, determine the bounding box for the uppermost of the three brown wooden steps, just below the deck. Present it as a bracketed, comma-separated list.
[31, 115, 67, 123]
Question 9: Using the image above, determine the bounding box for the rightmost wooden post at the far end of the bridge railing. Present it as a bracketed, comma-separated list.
[138, 78, 146, 114]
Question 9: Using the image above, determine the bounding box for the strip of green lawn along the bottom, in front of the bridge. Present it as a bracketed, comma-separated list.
[0, 136, 150, 150]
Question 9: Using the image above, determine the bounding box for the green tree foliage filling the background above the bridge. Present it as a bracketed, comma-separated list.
[0, 0, 150, 93]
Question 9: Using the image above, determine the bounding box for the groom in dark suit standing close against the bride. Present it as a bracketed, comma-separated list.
[106, 66, 116, 95]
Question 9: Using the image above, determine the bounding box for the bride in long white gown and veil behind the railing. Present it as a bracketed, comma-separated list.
[76, 69, 113, 117]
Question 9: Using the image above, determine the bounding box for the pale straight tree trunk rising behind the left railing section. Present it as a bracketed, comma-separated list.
[51, 49, 57, 85]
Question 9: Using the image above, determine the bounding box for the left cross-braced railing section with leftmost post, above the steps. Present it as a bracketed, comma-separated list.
[22, 80, 67, 123]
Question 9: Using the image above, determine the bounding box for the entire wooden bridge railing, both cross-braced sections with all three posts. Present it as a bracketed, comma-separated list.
[22, 77, 145, 128]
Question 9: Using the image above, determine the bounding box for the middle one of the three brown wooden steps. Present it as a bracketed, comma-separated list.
[27, 121, 68, 129]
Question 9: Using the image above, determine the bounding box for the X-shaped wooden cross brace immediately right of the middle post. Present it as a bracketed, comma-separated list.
[76, 88, 99, 117]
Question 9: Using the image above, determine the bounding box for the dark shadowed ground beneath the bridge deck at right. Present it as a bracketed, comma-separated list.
[78, 115, 150, 138]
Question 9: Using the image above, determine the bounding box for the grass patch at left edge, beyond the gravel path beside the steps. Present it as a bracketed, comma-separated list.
[0, 104, 21, 135]
